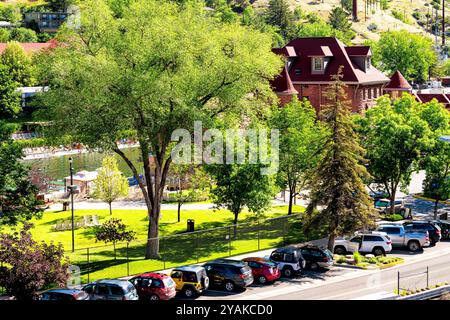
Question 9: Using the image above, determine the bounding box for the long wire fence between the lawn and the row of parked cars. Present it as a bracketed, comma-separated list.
[66, 214, 308, 284]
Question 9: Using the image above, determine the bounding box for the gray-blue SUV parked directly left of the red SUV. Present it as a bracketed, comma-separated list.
[81, 279, 139, 300]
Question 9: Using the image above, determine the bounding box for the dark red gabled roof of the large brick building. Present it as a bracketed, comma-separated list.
[284, 37, 389, 83]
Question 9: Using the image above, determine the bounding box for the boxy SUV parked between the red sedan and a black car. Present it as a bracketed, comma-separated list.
[270, 247, 306, 278]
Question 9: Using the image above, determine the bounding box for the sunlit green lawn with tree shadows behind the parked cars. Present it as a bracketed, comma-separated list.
[22, 206, 305, 283]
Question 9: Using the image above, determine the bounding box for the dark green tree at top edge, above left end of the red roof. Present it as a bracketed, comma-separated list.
[265, 0, 294, 40]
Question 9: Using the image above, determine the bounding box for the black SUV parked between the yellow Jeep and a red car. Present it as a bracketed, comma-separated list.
[203, 259, 253, 291]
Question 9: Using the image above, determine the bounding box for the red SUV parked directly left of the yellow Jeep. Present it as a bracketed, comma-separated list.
[129, 273, 176, 300]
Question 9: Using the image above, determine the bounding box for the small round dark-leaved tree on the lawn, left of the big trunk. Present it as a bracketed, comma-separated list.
[94, 218, 136, 260]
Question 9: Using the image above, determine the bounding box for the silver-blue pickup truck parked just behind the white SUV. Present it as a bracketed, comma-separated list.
[377, 224, 430, 252]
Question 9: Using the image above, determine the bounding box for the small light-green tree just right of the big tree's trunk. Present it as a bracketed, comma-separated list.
[171, 164, 211, 222]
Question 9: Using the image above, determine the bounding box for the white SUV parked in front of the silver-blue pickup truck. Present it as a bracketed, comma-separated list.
[333, 231, 392, 256]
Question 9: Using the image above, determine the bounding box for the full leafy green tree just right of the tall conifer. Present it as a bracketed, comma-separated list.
[356, 94, 449, 216]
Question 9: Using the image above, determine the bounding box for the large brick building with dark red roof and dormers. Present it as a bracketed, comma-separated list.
[272, 37, 389, 112]
